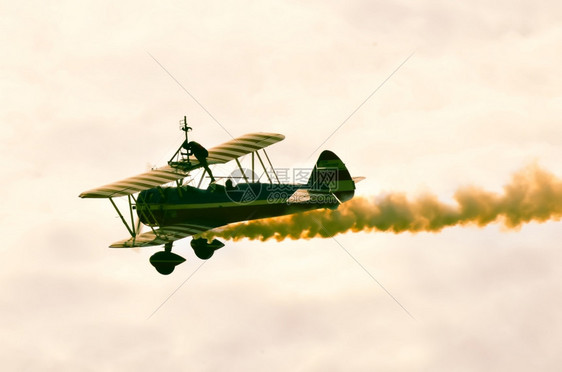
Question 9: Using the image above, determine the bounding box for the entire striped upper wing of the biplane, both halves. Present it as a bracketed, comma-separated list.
[79, 132, 285, 198]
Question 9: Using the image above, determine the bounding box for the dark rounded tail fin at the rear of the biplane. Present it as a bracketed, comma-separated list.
[306, 150, 355, 202]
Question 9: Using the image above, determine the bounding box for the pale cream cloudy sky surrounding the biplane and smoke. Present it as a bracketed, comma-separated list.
[0, 0, 562, 371]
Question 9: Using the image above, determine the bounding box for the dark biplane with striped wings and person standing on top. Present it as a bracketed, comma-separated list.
[79, 117, 362, 275]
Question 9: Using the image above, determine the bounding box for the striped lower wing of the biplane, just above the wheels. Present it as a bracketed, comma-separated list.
[109, 224, 213, 248]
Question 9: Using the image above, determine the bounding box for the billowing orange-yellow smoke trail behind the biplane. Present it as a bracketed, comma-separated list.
[204, 166, 562, 241]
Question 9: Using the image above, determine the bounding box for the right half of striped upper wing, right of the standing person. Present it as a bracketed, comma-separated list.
[207, 132, 285, 164]
